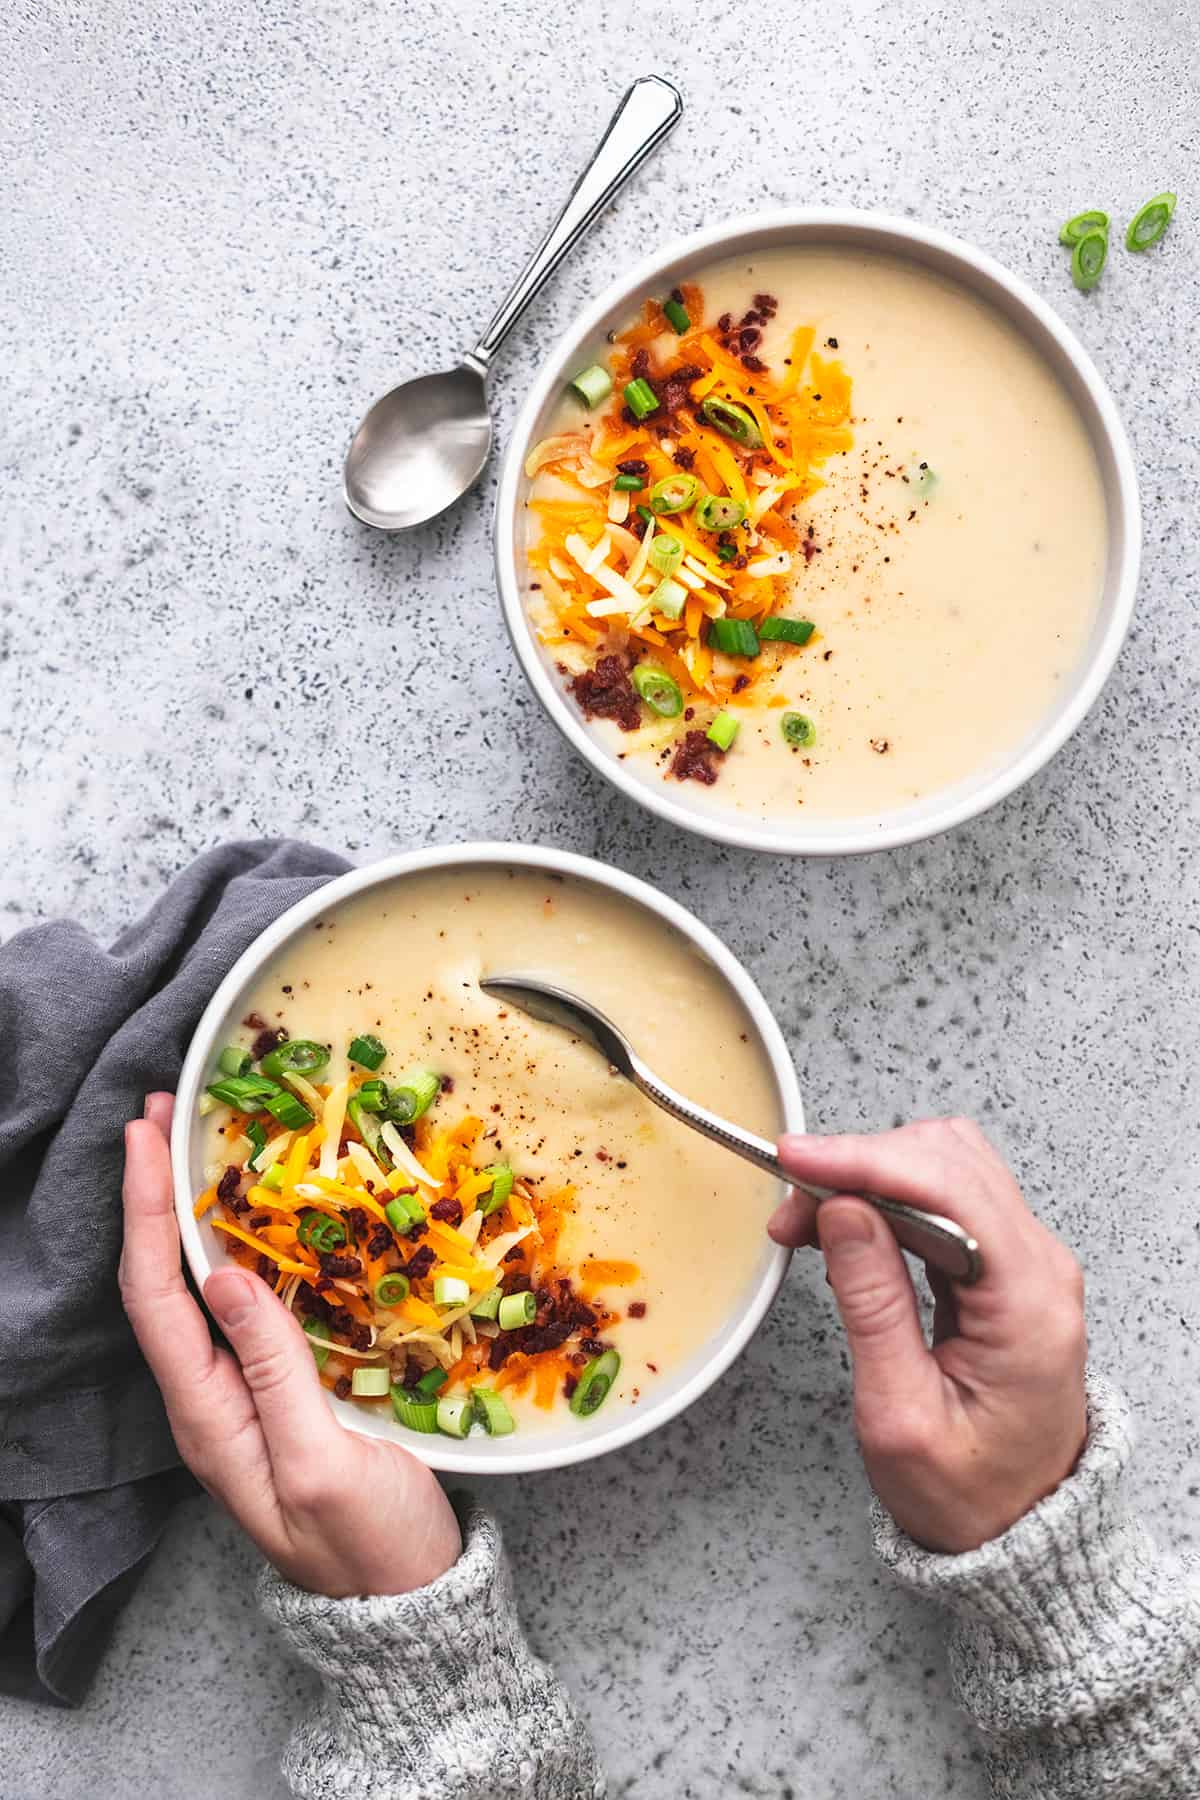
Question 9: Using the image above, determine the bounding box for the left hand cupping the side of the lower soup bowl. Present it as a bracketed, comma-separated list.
[119, 1094, 462, 1598]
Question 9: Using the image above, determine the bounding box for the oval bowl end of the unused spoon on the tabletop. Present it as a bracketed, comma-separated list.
[344, 362, 491, 531]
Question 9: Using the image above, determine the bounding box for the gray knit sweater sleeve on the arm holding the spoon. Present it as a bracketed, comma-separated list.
[874, 1381, 1200, 1800]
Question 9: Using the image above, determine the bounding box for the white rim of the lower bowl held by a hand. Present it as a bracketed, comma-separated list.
[171, 841, 804, 1476]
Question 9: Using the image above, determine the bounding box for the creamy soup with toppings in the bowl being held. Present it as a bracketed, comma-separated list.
[196, 868, 781, 1436]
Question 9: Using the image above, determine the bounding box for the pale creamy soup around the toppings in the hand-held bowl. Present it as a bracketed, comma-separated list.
[205, 868, 781, 1431]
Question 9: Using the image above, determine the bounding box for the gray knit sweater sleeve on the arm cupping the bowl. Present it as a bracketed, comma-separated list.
[259, 1512, 606, 1800]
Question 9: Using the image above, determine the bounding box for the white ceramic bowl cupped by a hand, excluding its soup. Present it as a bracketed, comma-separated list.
[171, 844, 804, 1474]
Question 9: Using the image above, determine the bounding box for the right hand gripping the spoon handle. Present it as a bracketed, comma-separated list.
[770, 1120, 1087, 1552]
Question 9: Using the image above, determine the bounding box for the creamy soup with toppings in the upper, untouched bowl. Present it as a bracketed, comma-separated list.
[527, 248, 1106, 823]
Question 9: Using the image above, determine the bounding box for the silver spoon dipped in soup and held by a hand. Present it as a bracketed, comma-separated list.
[479, 976, 984, 1287]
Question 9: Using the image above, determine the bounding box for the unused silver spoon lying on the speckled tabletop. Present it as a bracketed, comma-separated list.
[344, 76, 684, 531]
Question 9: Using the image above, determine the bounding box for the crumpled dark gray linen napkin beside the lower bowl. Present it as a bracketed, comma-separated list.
[0, 841, 347, 1705]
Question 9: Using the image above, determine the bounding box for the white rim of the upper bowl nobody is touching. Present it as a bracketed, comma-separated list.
[493, 207, 1142, 857]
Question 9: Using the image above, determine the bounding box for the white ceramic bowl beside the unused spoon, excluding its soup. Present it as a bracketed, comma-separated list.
[495, 207, 1141, 857]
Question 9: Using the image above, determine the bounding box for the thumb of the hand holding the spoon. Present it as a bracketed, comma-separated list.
[817, 1199, 932, 1417]
